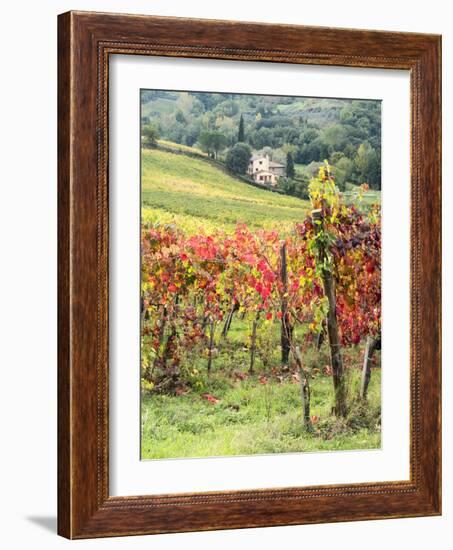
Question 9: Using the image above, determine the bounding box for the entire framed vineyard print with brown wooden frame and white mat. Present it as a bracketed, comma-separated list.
[58, 12, 441, 538]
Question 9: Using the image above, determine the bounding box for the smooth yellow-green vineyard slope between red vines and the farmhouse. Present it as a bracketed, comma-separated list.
[142, 149, 308, 232]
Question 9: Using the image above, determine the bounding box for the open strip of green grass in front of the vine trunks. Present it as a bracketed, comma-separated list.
[142, 369, 380, 459]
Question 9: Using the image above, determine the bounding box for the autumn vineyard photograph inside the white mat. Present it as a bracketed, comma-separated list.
[137, 89, 381, 460]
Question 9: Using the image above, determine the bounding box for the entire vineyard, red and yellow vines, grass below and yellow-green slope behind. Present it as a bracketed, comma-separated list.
[142, 151, 381, 458]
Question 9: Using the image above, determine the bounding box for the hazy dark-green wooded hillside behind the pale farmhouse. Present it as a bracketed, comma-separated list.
[141, 90, 381, 191]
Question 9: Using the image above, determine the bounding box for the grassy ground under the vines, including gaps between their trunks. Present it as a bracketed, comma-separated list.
[141, 318, 381, 459]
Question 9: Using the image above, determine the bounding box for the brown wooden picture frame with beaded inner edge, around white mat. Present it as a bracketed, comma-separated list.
[58, 12, 441, 538]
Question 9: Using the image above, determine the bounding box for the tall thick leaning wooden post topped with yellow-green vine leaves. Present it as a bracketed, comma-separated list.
[312, 210, 346, 416]
